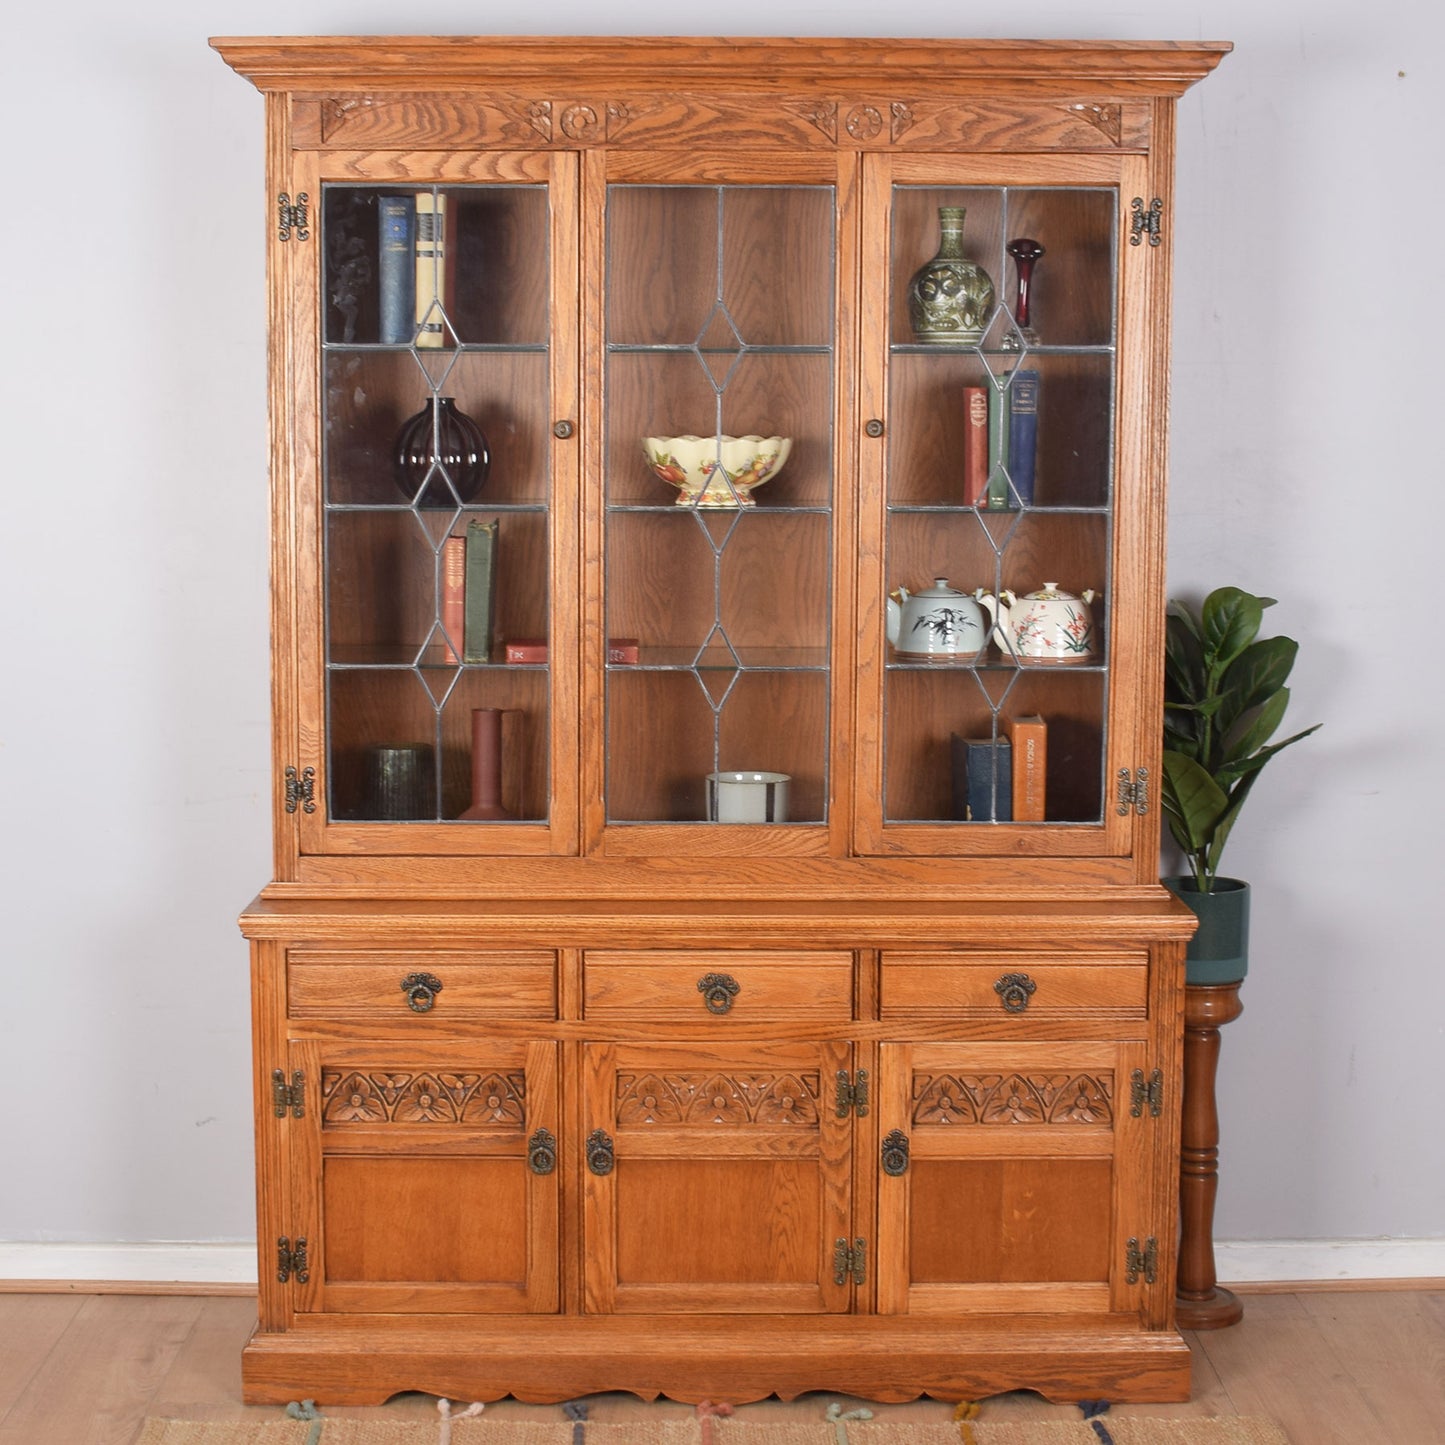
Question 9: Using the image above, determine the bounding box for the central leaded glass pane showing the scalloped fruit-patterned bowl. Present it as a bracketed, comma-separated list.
[604, 185, 835, 825]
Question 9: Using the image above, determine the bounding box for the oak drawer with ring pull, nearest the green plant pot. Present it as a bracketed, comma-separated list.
[879, 952, 1149, 1019]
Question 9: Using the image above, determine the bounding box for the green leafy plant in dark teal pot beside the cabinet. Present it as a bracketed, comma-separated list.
[1162, 587, 1319, 984]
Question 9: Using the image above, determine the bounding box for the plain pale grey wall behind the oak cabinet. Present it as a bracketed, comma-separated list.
[0, 0, 1445, 1241]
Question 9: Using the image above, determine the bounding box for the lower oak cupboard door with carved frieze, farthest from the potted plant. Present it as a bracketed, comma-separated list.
[290, 1039, 558, 1314]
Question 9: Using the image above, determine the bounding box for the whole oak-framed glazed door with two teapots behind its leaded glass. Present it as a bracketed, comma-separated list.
[858, 156, 1162, 855]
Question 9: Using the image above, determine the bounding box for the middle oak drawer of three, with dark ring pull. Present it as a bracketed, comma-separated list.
[584, 949, 853, 1023]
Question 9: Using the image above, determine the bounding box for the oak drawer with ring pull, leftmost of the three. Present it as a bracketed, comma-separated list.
[286, 948, 556, 1022]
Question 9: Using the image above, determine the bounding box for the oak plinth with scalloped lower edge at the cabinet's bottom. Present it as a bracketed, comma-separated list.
[243, 1315, 1189, 1405]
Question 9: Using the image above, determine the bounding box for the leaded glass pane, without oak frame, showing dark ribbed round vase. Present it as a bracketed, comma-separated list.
[321, 184, 552, 825]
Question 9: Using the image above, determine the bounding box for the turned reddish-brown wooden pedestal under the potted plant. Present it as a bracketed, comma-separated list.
[1175, 983, 1244, 1329]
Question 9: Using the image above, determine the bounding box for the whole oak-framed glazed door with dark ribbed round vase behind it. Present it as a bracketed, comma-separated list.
[288, 153, 578, 854]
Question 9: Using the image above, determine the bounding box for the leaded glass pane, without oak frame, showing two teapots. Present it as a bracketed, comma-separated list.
[883, 185, 1118, 832]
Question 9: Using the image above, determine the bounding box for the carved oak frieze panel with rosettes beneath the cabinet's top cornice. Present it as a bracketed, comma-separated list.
[292, 87, 1149, 152]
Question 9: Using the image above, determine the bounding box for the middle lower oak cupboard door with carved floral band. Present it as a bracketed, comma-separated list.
[584, 1042, 855, 1314]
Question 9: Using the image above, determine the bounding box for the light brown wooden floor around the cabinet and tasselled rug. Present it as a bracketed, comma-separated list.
[0, 1287, 1445, 1445]
